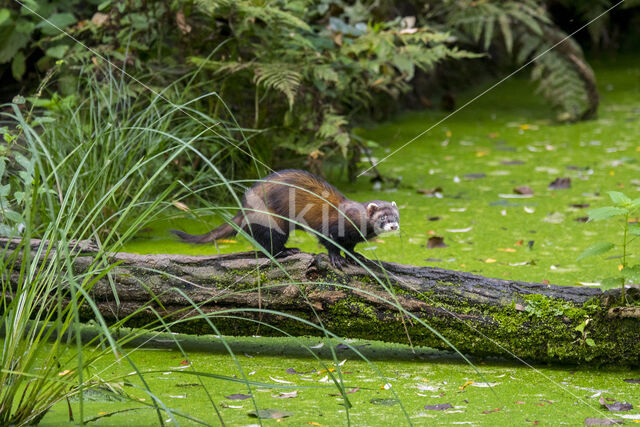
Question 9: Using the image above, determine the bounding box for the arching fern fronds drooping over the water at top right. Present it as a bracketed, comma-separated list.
[434, 0, 597, 121]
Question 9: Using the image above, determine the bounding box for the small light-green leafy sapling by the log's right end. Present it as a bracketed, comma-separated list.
[578, 191, 640, 303]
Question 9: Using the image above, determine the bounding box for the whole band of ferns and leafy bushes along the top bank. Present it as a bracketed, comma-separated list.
[0, 0, 597, 179]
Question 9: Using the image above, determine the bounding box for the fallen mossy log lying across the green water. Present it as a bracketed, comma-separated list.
[0, 240, 640, 365]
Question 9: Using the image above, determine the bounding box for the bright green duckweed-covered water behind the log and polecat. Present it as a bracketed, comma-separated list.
[123, 59, 640, 285]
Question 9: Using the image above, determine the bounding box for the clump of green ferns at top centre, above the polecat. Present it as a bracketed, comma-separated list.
[190, 0, 475, 167]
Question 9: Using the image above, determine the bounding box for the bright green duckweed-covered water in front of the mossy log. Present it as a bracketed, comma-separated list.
[41, 335, 640, 426]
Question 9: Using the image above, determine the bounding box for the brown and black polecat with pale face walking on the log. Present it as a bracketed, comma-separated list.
[171, 169, 400, 268]
